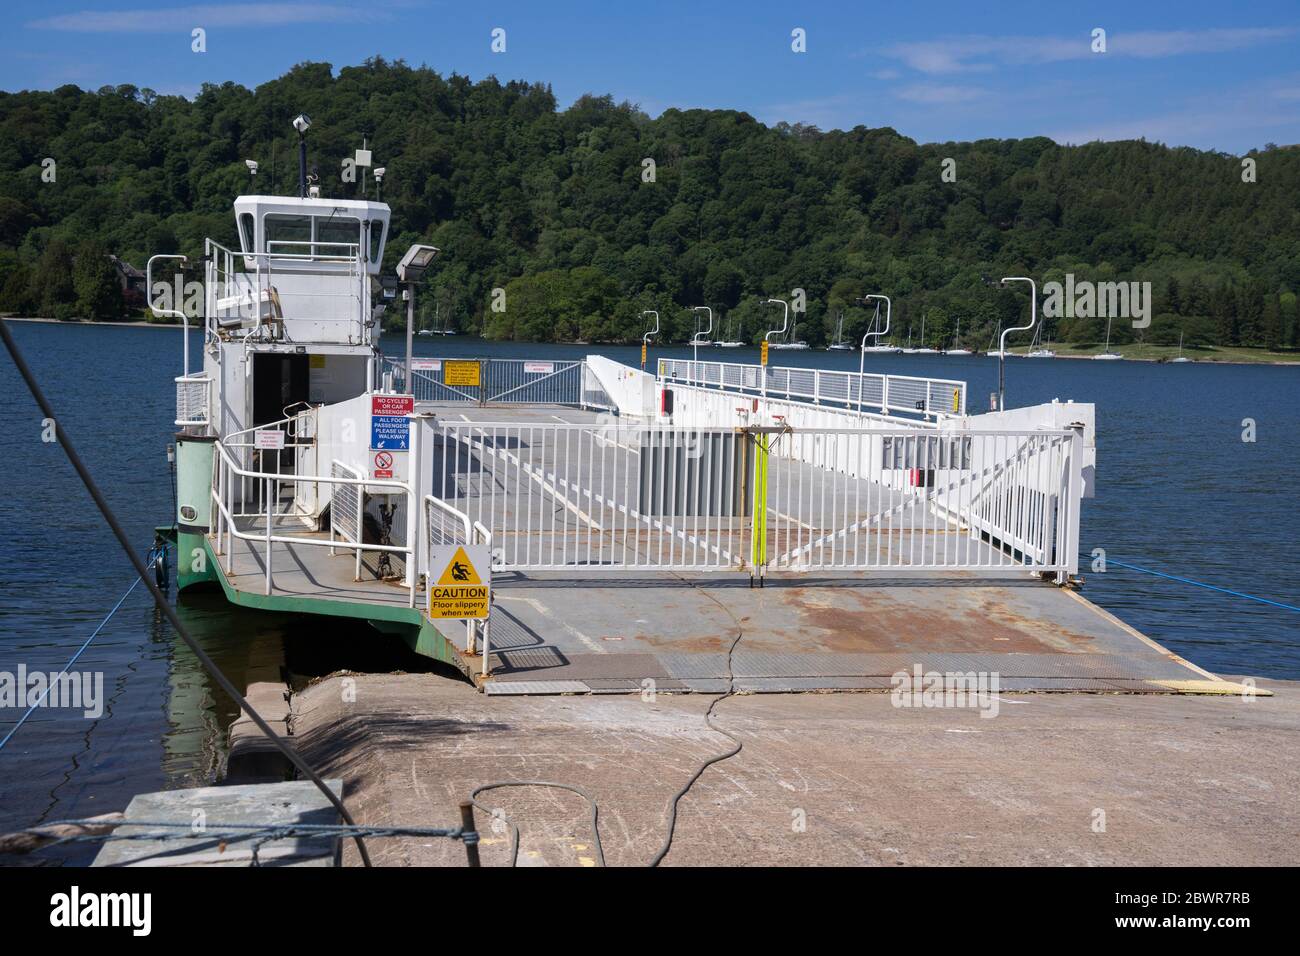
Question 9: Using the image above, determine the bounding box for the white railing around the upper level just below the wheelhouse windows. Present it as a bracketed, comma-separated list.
[204, 239, 372, 345]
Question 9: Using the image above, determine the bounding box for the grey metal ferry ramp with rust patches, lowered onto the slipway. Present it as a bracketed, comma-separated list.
[485, 572, 1209, 695]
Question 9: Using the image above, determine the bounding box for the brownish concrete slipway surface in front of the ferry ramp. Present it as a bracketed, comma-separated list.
[290, 674, 1300, 866]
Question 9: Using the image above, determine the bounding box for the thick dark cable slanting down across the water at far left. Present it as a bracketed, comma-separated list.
[0, 319, 371, 866]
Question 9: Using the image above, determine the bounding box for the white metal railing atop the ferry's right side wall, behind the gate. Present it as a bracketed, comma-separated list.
[658, 359, 966, 418]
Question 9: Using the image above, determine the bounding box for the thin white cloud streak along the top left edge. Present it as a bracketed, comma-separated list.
[27, 3, 377, 34]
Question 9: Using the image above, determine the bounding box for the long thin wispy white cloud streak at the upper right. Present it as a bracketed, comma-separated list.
[884, 27, 1295, 74]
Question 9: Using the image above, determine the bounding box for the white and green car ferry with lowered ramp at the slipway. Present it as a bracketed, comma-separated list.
[148, 128, 1248, 712]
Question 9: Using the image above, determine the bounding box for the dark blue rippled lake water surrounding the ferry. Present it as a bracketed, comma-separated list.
[0, 323, 1300, 860]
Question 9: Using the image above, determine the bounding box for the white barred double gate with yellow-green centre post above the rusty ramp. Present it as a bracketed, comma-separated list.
[430, 421, 1083, 578]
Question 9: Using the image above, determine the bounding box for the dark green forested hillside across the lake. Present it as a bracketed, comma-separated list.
[0, 59, 1300, 349]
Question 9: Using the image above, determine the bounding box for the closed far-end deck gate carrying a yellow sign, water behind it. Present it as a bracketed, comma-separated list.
[384, 358, 612, 408]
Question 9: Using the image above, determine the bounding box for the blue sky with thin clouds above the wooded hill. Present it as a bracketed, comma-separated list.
[0, 0, 1300, 152]
